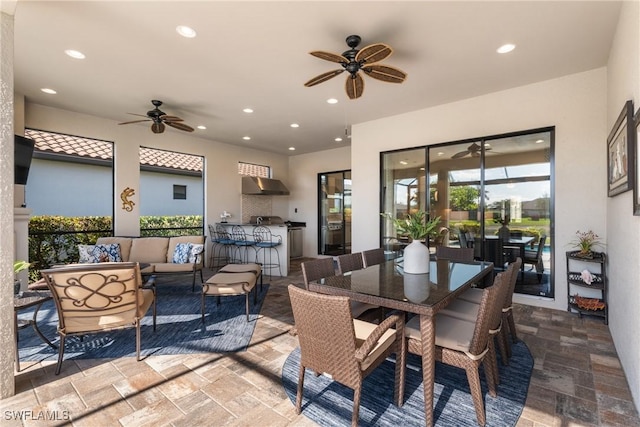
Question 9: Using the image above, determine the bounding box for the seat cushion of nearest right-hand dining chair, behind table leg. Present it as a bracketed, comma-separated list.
[404, 314, 476, 353]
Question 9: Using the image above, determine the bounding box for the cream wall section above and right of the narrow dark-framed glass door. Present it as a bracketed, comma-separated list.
[287, 146, 350, 257]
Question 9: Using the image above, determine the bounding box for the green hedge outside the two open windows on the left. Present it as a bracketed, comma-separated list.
[29, 215, 203, 282]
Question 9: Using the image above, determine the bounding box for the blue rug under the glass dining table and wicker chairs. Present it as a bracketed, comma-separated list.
[282, 341, 533, 427]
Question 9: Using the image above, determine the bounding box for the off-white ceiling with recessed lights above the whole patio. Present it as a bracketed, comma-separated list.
[8, 0, 620, 154]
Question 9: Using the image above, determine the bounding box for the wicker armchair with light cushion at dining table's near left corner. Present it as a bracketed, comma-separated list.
[289, 285, 406, 427]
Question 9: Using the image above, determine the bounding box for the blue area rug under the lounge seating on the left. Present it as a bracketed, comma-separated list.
[18, 284, 269, 361]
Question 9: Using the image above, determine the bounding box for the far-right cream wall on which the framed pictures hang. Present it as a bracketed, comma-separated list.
[606, 1, 640, 408]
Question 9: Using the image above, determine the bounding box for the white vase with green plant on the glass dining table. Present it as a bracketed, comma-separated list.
[381, 210, 440, 274]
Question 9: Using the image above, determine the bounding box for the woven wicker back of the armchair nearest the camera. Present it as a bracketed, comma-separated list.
[289, 285, 361, 388]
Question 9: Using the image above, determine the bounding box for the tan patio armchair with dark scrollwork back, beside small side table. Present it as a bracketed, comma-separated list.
[41, 263, 156, 375]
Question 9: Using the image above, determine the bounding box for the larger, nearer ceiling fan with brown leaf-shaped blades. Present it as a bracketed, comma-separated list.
[304, 35, 407, 99]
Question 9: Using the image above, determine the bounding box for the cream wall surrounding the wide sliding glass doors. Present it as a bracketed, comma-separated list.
[351, 68, 607, 310]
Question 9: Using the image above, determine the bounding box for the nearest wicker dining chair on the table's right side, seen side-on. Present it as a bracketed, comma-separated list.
[405, 273, 508, 426]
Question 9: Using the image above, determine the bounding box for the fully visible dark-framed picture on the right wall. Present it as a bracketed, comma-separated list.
[607, 100, 637, 197]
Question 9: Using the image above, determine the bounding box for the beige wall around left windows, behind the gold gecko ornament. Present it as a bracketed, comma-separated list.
[21, 102, 290, 236]
